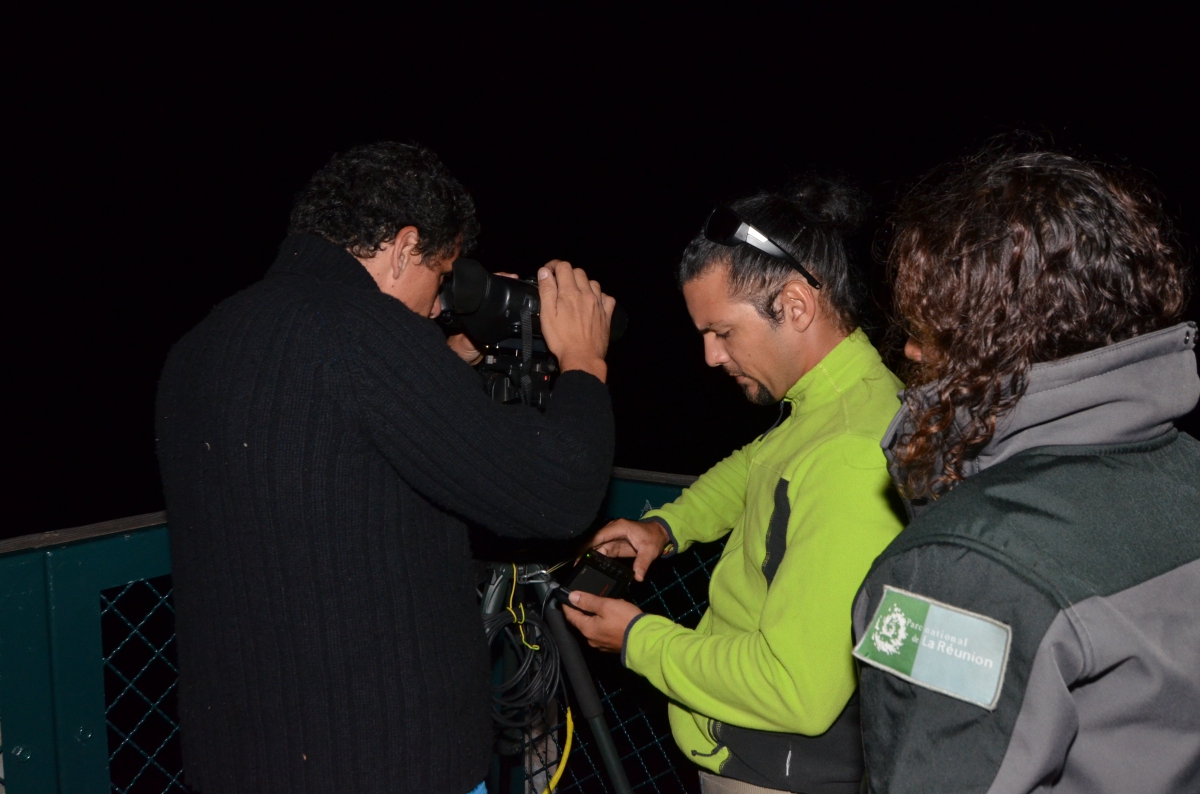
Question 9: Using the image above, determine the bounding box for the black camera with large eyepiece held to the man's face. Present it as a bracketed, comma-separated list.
[438, 259, 629, 410]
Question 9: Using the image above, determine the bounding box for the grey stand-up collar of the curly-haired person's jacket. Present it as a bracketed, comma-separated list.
[881, 323, 1200, 498]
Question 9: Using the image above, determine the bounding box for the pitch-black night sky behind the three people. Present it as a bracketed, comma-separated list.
[0, 4, 1200, 536]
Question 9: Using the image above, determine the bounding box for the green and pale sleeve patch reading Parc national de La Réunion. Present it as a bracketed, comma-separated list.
[854, 585, 1013, 711]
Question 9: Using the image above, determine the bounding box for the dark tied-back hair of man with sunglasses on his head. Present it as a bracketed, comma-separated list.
[679, 176, 868, 333]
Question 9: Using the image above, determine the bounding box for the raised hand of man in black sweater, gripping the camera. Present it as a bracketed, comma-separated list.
[538, 259, 617, 380]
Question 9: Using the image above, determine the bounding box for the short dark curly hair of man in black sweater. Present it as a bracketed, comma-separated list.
[288, 142, 479, 266]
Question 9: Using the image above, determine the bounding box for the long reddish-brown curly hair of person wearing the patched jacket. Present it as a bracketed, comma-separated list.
[889, 150, 1188, 498]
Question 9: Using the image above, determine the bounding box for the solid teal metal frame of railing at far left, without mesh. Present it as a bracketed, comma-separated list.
[0, 513, 178, 794]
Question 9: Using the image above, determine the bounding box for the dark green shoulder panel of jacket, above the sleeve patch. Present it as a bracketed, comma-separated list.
[869, 429, 1200, 607]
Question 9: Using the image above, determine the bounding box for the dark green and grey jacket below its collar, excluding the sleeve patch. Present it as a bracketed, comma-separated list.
[854, 431, 1200, 793]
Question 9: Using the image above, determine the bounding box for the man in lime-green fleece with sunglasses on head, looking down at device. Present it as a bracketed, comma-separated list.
[565, 180, 901, 794]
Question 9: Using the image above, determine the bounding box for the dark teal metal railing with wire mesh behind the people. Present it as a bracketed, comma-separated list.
[0, 469, 720, 794]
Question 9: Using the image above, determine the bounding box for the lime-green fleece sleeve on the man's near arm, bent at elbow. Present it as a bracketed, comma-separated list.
[625, 435, 900, 735]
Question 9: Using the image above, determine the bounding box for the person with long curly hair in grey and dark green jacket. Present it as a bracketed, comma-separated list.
[853, 152, 1200, 794]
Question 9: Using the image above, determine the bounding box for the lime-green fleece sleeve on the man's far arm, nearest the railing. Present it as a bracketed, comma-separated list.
[642, 444, 754, 552]
